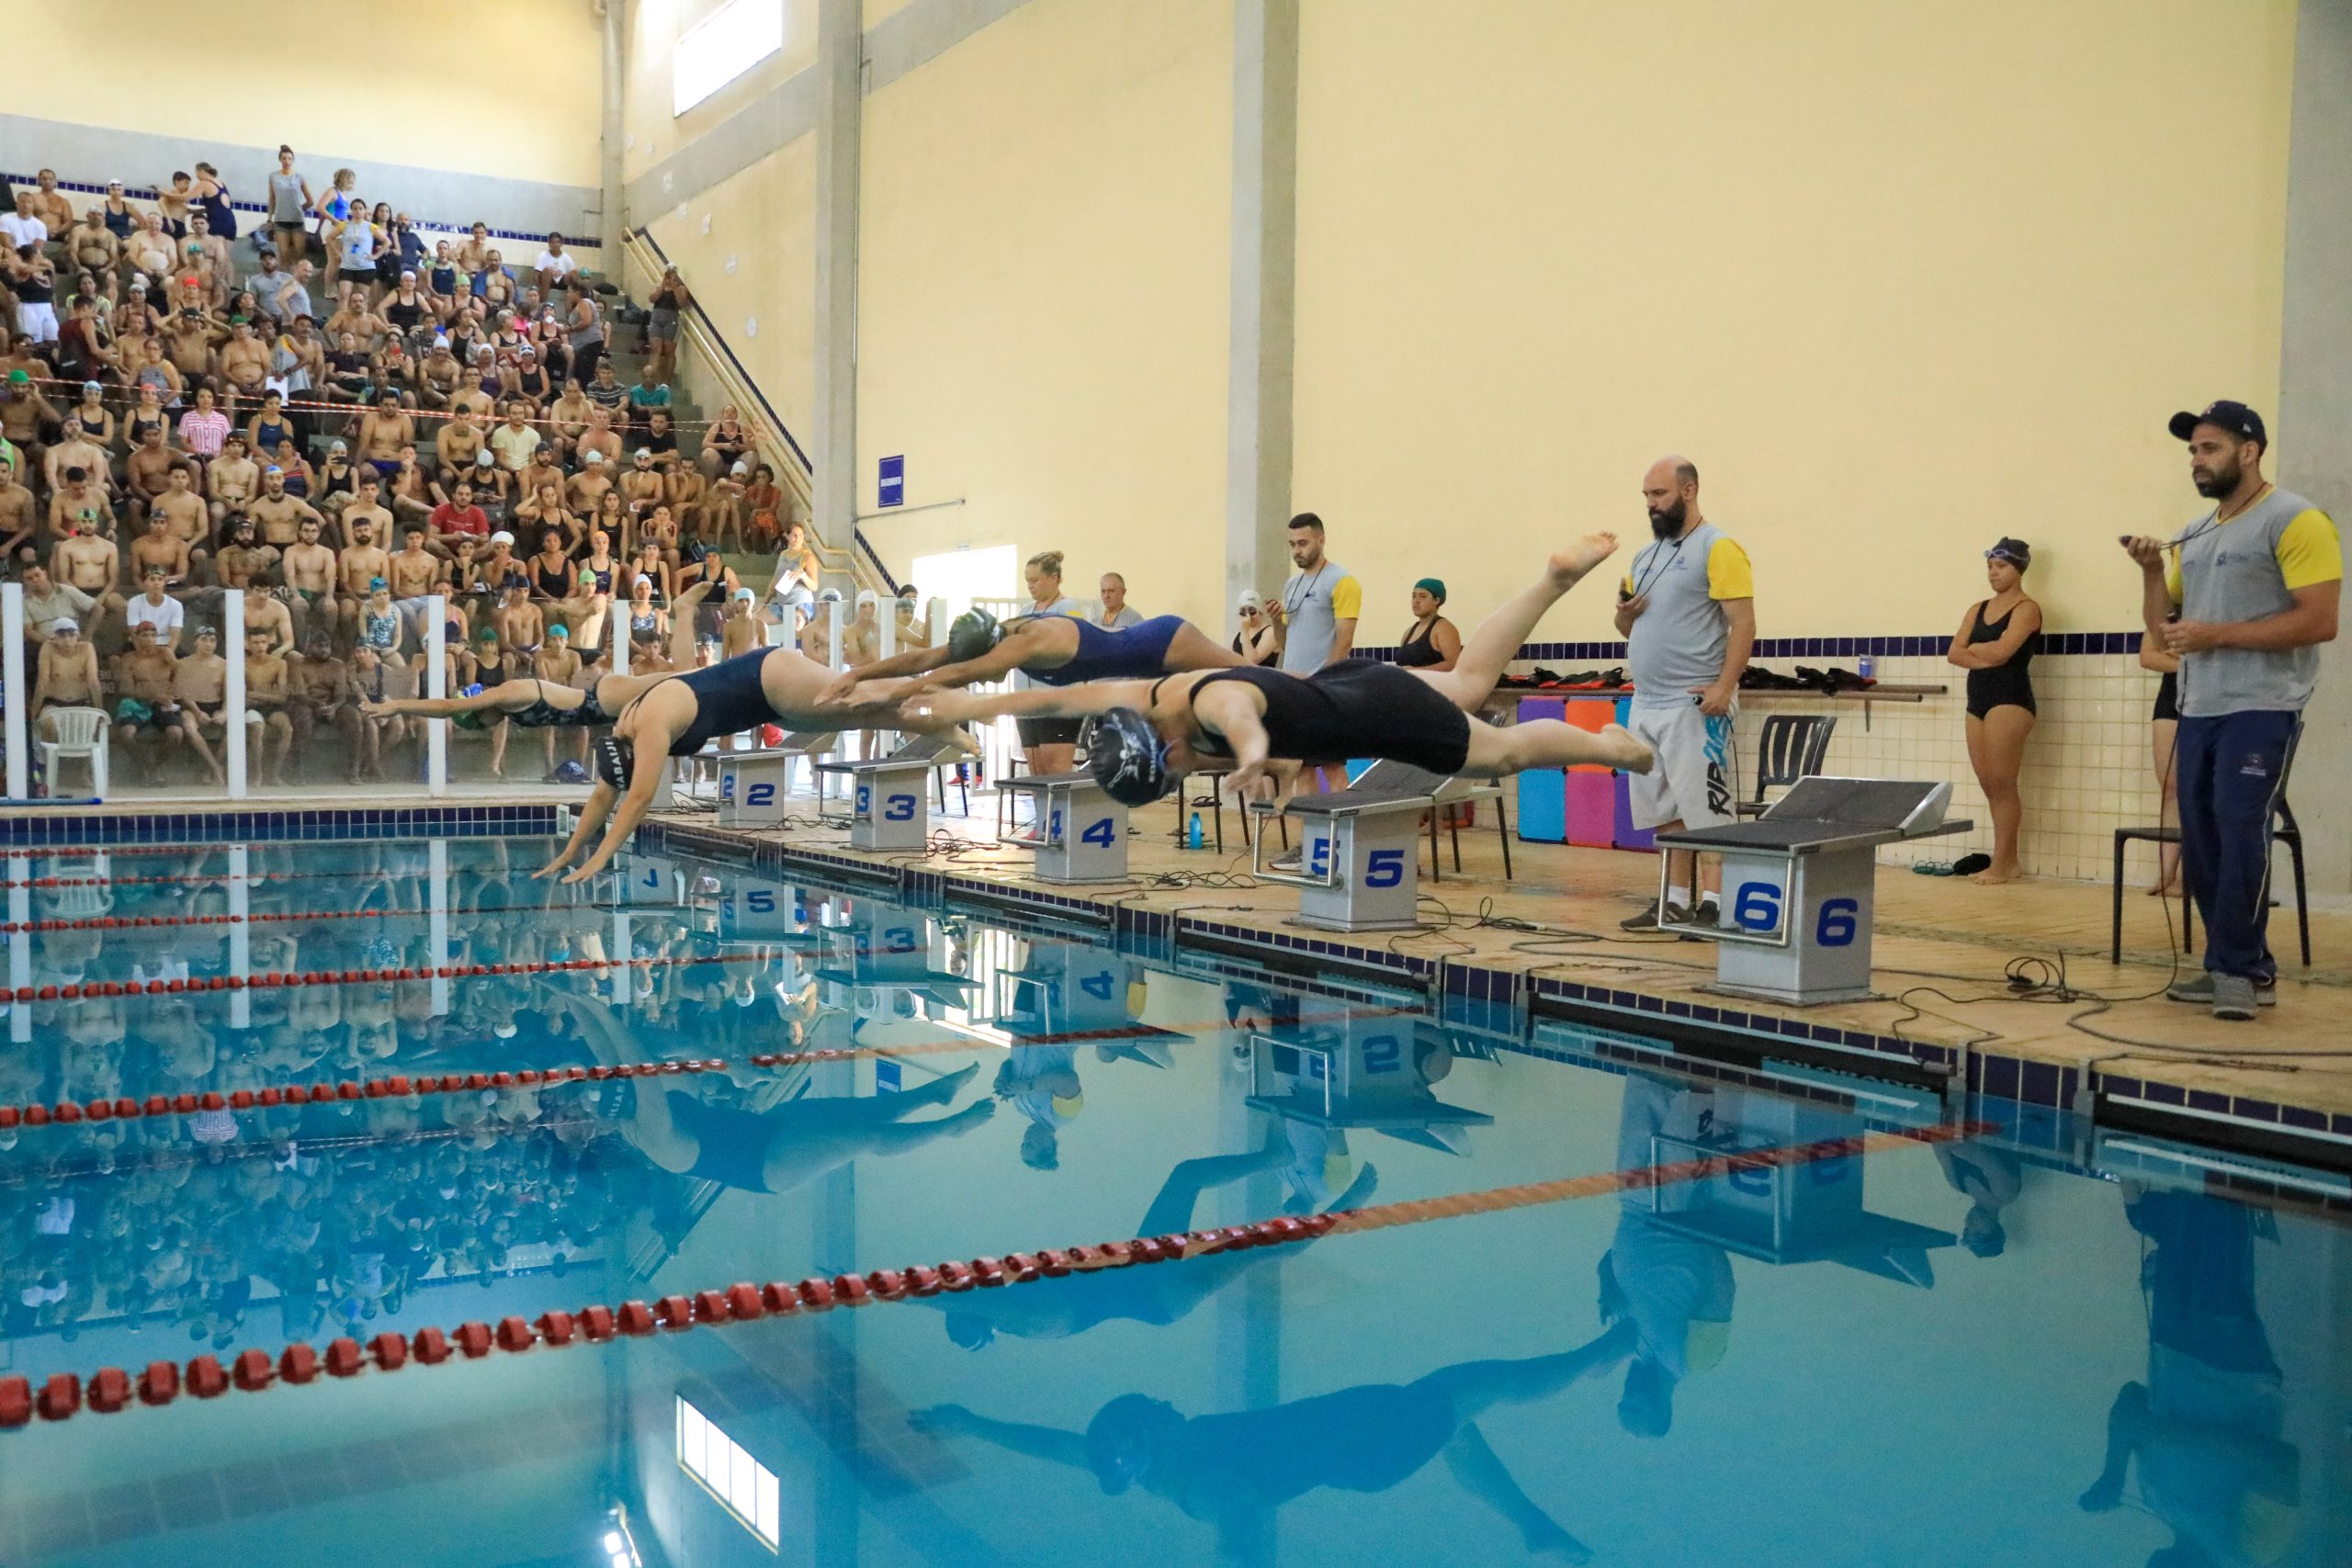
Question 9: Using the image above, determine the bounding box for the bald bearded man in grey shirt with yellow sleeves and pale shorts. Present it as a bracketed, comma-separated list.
[1616, 458, 1757, 931]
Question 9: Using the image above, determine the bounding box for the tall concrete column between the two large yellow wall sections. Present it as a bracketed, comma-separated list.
[1226, 0, 1298, 606]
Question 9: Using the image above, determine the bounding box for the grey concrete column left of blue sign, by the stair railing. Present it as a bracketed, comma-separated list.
[809, 0, 865, 550]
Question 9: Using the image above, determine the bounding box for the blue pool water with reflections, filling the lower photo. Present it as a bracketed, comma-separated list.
[0, 840, 2352, 1568]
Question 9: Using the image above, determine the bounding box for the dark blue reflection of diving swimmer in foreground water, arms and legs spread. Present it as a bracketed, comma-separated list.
[912, 1328, 1633, 1563]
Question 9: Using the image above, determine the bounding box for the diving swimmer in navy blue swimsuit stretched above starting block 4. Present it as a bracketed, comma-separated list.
[826, 609, 1242, 698]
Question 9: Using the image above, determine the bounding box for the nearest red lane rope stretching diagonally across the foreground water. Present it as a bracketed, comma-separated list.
[0, 1122, 1995, 1429]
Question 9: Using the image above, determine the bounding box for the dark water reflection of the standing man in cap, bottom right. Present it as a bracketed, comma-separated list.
[2082, 1190, 2302, 1568]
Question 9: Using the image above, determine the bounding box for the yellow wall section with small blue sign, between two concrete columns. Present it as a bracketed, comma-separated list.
[858, 0, 1232, 616]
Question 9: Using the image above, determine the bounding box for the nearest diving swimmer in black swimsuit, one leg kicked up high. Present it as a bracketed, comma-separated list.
[908, 534, 1654, 807]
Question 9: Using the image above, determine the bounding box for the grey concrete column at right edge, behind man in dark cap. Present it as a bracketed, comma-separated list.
[2272, 0, 2352, 893]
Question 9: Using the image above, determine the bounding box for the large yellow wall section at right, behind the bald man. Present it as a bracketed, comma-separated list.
[1296, 0, 2296, 642]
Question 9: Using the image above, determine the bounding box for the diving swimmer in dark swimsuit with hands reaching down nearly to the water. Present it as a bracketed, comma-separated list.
[534, 639, 981, 882]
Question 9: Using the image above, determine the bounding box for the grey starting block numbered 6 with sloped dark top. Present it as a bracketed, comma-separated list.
[1658, 778, 1973, 1006]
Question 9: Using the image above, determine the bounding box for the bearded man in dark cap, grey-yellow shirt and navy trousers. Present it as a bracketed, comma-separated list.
[2124, 402, 2343, 1022]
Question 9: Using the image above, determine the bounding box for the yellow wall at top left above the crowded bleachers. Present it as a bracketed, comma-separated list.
[0, 0, 605, 200]
